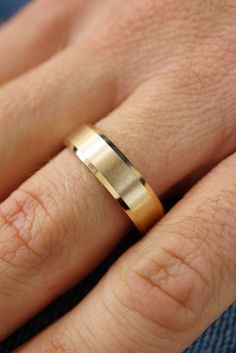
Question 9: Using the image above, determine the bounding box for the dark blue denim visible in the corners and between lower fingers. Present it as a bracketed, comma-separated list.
[0, 0, 236, 353]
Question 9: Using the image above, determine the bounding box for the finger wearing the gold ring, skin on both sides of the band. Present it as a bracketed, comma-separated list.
[0, 69, 236, 337]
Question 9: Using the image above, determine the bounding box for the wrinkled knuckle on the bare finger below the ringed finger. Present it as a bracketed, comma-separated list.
[114, 237, 214, 334]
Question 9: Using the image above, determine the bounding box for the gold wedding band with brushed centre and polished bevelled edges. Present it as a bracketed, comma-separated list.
[65, 125, 164, 234]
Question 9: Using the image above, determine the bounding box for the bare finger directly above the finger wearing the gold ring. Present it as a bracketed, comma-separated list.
[0, 43, 115, 200]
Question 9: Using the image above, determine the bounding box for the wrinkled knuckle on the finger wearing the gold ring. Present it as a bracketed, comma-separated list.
[0, 179, 60, 267]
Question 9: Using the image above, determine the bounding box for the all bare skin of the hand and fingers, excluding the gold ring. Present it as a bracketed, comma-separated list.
[0, 0, 236, 353]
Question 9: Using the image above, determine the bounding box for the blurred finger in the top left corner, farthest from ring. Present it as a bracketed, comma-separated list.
[0, 0, 83, 84]
